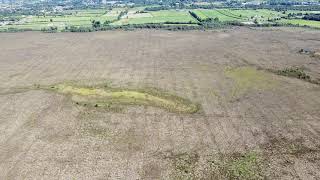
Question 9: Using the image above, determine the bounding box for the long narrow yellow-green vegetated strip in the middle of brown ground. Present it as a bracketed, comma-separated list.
[43, 84, 199, 113]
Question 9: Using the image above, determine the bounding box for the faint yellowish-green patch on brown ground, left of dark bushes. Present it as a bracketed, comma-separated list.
[225, 67, 277, 97]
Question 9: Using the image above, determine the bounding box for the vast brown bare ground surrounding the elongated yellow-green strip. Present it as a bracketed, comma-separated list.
[0, 28, 320, 179]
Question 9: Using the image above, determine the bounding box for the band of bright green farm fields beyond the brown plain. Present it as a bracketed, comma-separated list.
[0, 6, 320, 31]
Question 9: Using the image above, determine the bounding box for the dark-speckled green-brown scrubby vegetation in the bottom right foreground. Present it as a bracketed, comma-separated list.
[164, 137, 319, 180]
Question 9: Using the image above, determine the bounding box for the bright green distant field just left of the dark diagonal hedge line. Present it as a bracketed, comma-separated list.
[114, 10, 197, 25]
